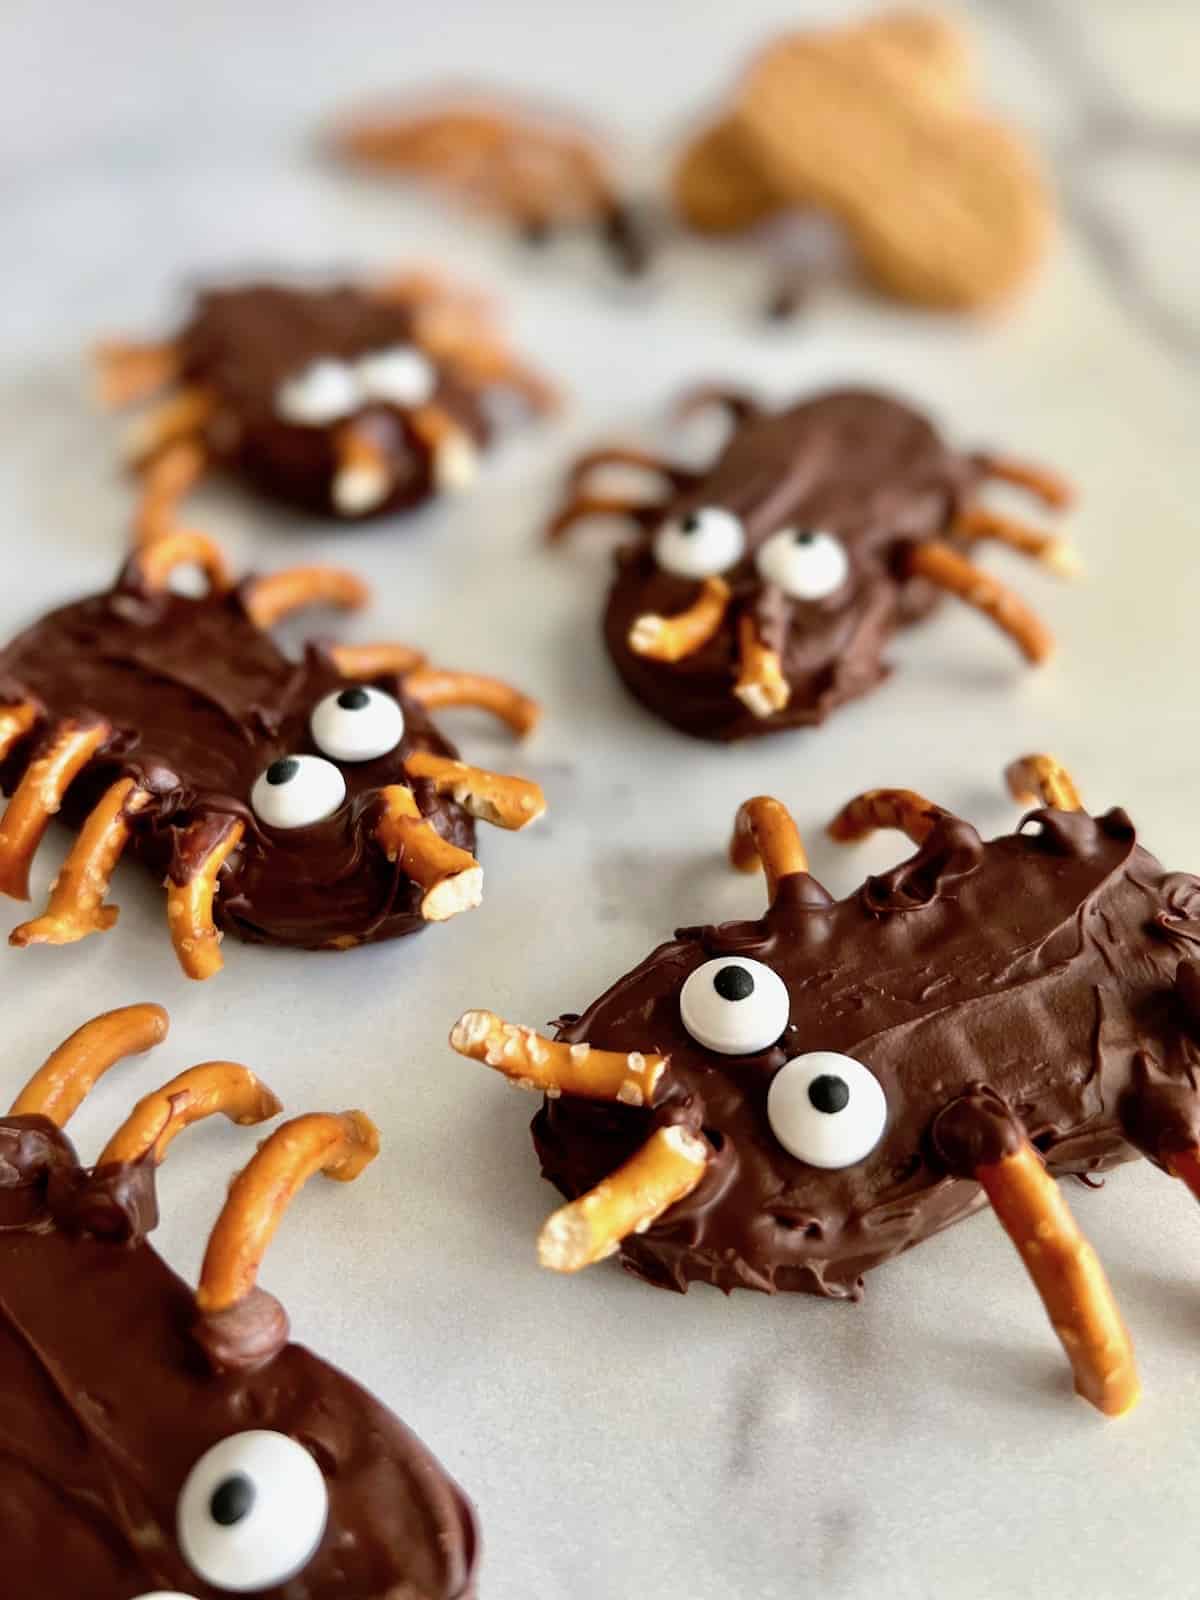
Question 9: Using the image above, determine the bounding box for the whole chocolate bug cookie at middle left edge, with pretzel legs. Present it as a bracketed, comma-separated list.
[0, 533, 544, 978]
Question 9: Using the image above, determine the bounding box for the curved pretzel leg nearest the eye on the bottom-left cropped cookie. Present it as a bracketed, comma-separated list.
[195, 1110, 379, 1312]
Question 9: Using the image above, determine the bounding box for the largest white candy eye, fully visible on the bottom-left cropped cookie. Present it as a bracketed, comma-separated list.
[176, 1429, 330, 1594]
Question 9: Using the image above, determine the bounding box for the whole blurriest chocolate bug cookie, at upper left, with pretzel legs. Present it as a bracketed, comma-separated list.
[98, 274, 555, 534]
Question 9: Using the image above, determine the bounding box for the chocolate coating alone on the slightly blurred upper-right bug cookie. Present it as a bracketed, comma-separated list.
[605, 389, 982, 739]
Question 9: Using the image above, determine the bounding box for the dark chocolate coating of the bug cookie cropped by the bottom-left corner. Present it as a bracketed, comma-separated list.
[0, 1152, 478, 1600]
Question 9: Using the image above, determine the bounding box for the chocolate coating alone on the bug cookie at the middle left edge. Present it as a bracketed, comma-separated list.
[0, 568, 475, 949]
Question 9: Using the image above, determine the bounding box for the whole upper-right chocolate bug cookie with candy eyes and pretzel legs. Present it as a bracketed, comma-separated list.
[550, 389, 1074, 739]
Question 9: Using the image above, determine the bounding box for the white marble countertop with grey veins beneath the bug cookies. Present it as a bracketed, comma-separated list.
[0, 0, 1200, 1600]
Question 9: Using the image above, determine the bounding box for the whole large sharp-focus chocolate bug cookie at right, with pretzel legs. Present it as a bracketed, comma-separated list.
[451, 757, 1200, 1413]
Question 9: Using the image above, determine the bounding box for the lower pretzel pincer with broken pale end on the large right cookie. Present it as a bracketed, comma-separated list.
[538, 1125, 709, 1272]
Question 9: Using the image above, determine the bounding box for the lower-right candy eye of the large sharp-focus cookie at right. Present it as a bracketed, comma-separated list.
[766, 1050, 888, 1168]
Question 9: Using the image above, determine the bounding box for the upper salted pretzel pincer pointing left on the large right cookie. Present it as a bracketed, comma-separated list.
[450, 1011, 669, 1106]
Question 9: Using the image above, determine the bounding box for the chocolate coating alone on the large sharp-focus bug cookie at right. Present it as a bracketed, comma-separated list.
[533, 810, 1200, 1298]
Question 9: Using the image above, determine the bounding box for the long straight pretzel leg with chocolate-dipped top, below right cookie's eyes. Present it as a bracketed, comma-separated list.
[933, 1091, 1141, 1416]
